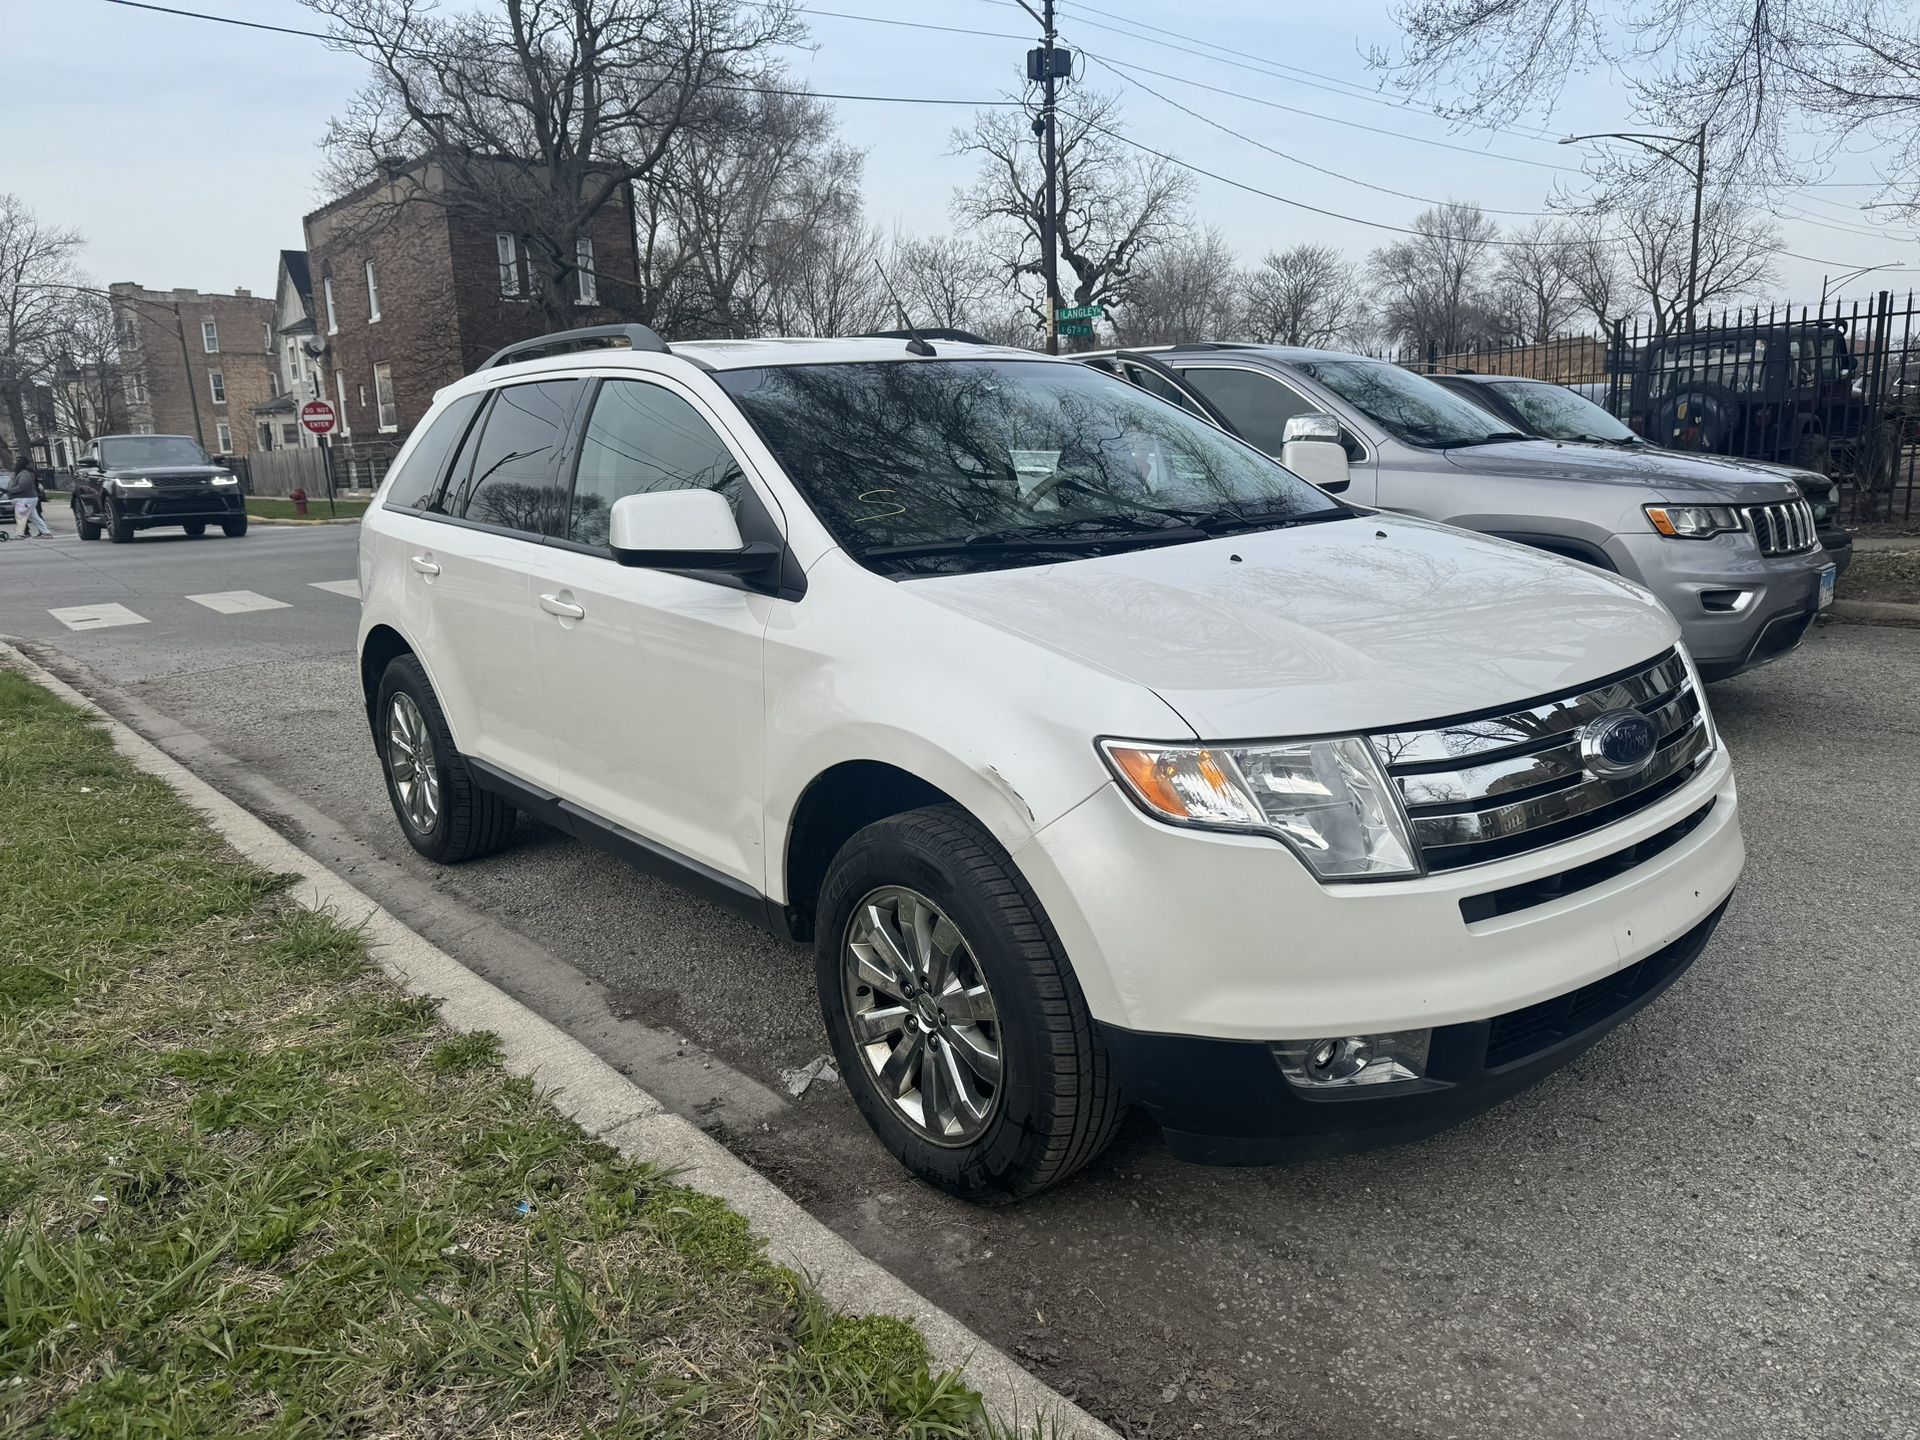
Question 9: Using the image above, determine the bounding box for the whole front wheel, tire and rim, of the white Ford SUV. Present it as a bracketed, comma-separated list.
[814, 804, 1125, 1202]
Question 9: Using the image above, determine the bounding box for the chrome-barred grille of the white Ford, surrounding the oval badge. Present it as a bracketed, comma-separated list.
[1371, 653, 1713, 870]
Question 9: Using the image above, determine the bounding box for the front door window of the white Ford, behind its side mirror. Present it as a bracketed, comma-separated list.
[566, 380, 743, 547]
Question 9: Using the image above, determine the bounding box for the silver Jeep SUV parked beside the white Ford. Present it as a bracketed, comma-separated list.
[1077, 344, 1837, 680]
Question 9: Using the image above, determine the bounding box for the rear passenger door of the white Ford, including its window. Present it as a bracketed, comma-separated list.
[407, 378, 584, 785]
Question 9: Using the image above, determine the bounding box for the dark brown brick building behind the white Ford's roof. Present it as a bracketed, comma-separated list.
[305, 161, 637, 486]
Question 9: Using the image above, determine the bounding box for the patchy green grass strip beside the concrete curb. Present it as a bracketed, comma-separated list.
[0, 668, 1036, 1440]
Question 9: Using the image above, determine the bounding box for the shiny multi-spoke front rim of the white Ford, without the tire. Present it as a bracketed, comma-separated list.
[841, 885, 1004, 1146]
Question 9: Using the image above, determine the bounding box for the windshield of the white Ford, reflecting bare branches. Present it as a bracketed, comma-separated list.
[714, 359, 1350, 570]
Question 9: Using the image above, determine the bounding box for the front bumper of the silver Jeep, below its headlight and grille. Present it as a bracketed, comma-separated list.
[1607, 532, 1839, 680]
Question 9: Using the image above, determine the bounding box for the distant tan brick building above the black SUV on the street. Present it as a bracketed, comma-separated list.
[108, 280, 278, 455]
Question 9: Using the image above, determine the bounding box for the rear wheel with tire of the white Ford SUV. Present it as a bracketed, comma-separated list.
[374, 655, 515, 866]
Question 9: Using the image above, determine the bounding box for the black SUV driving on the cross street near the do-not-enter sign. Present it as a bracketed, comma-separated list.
[73, 436, 246, 545]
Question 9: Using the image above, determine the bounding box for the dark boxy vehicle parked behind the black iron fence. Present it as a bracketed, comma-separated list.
[1626, 319, 1910, 482]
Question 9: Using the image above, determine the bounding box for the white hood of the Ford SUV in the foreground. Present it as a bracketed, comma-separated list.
[904, 515, 1678, 739]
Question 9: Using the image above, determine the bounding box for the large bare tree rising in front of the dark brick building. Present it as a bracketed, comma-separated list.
[303, 0, 803, 330]
